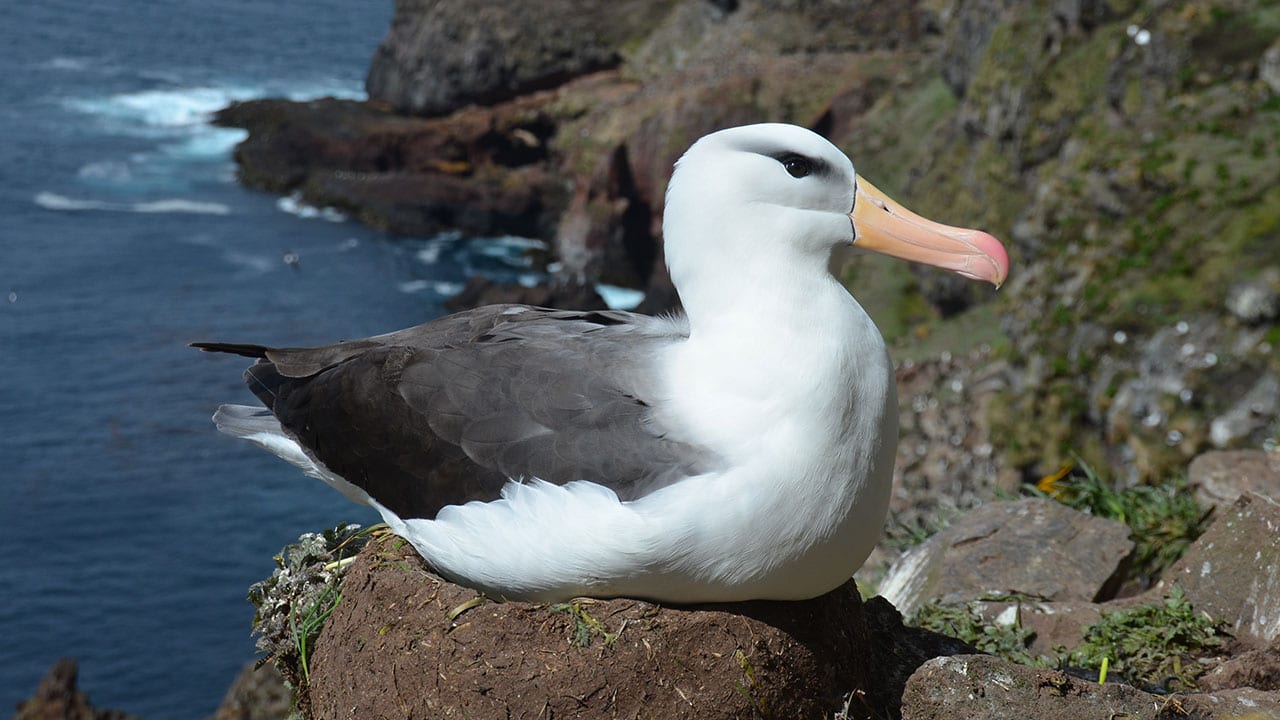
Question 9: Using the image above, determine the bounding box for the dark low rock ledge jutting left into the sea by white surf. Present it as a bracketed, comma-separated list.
[215, 95, 567, 236]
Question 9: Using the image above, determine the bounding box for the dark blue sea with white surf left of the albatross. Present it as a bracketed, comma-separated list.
[0, 0, 550, 720]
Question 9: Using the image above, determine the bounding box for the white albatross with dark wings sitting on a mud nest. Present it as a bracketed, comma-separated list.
[192, 123, 1009, 603]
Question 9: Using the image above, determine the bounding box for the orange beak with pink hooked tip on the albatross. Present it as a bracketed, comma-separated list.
[849, 176, 1009, 287]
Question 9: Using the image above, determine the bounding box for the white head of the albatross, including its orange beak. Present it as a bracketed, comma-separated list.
[663, 123, 1009, 319]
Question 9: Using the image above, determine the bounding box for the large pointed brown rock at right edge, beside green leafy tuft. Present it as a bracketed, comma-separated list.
[1151, 492, 1280, 643]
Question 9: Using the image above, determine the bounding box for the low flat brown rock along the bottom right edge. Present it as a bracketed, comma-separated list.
[902, 655, 1280, 720]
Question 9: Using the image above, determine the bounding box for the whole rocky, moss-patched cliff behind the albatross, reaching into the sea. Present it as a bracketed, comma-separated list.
[223, 0, 1280, 520]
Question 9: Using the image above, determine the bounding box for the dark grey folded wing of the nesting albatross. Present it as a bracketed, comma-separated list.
[221, 306, 719, 518]
